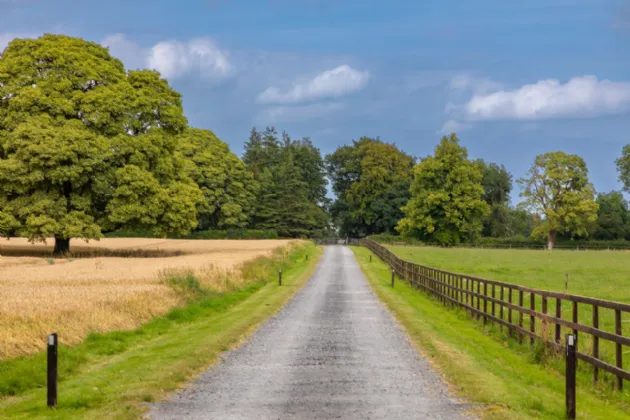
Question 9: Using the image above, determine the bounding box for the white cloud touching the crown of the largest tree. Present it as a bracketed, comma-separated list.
[102, 34, 233, 80]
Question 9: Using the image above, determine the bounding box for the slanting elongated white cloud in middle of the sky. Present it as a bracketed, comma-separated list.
[257, 65, 370, 104]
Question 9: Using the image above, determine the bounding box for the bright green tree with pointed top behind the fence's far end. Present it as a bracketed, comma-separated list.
[397, 133, 490, 244]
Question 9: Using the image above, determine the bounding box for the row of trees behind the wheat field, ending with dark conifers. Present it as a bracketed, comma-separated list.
[0, 35, 328, 253]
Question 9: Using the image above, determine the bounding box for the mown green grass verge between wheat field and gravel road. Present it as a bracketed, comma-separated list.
[0, 243, 322, 419]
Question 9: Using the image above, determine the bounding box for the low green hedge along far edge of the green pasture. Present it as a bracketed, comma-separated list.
[370, 234, 630, 249]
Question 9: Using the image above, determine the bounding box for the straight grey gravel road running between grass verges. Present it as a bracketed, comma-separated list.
[149, 246, 466, 420]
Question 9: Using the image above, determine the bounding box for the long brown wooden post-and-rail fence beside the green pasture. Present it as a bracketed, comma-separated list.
[359, 239, 630, 390]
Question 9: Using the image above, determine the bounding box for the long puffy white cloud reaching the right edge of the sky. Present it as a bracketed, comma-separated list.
[463, 76, 630, 121]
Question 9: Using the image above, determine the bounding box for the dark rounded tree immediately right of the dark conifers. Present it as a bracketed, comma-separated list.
[326, 137, 414, 236]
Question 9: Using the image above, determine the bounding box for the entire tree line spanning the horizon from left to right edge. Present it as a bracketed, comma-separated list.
[0, 35, 630, 253]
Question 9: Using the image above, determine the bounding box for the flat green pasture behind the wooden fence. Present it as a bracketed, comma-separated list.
[390, 246, 630, 381]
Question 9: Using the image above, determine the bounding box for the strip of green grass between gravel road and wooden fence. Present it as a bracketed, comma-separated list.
[353, 247, 630, 420]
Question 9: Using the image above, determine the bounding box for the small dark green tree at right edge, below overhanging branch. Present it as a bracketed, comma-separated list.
[594, 191, 630, 240]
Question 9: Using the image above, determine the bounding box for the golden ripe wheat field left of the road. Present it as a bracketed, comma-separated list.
[0, 238, 289, 360]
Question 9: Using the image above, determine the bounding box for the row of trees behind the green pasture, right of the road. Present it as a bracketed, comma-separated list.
[326, 134, 630, 248]
